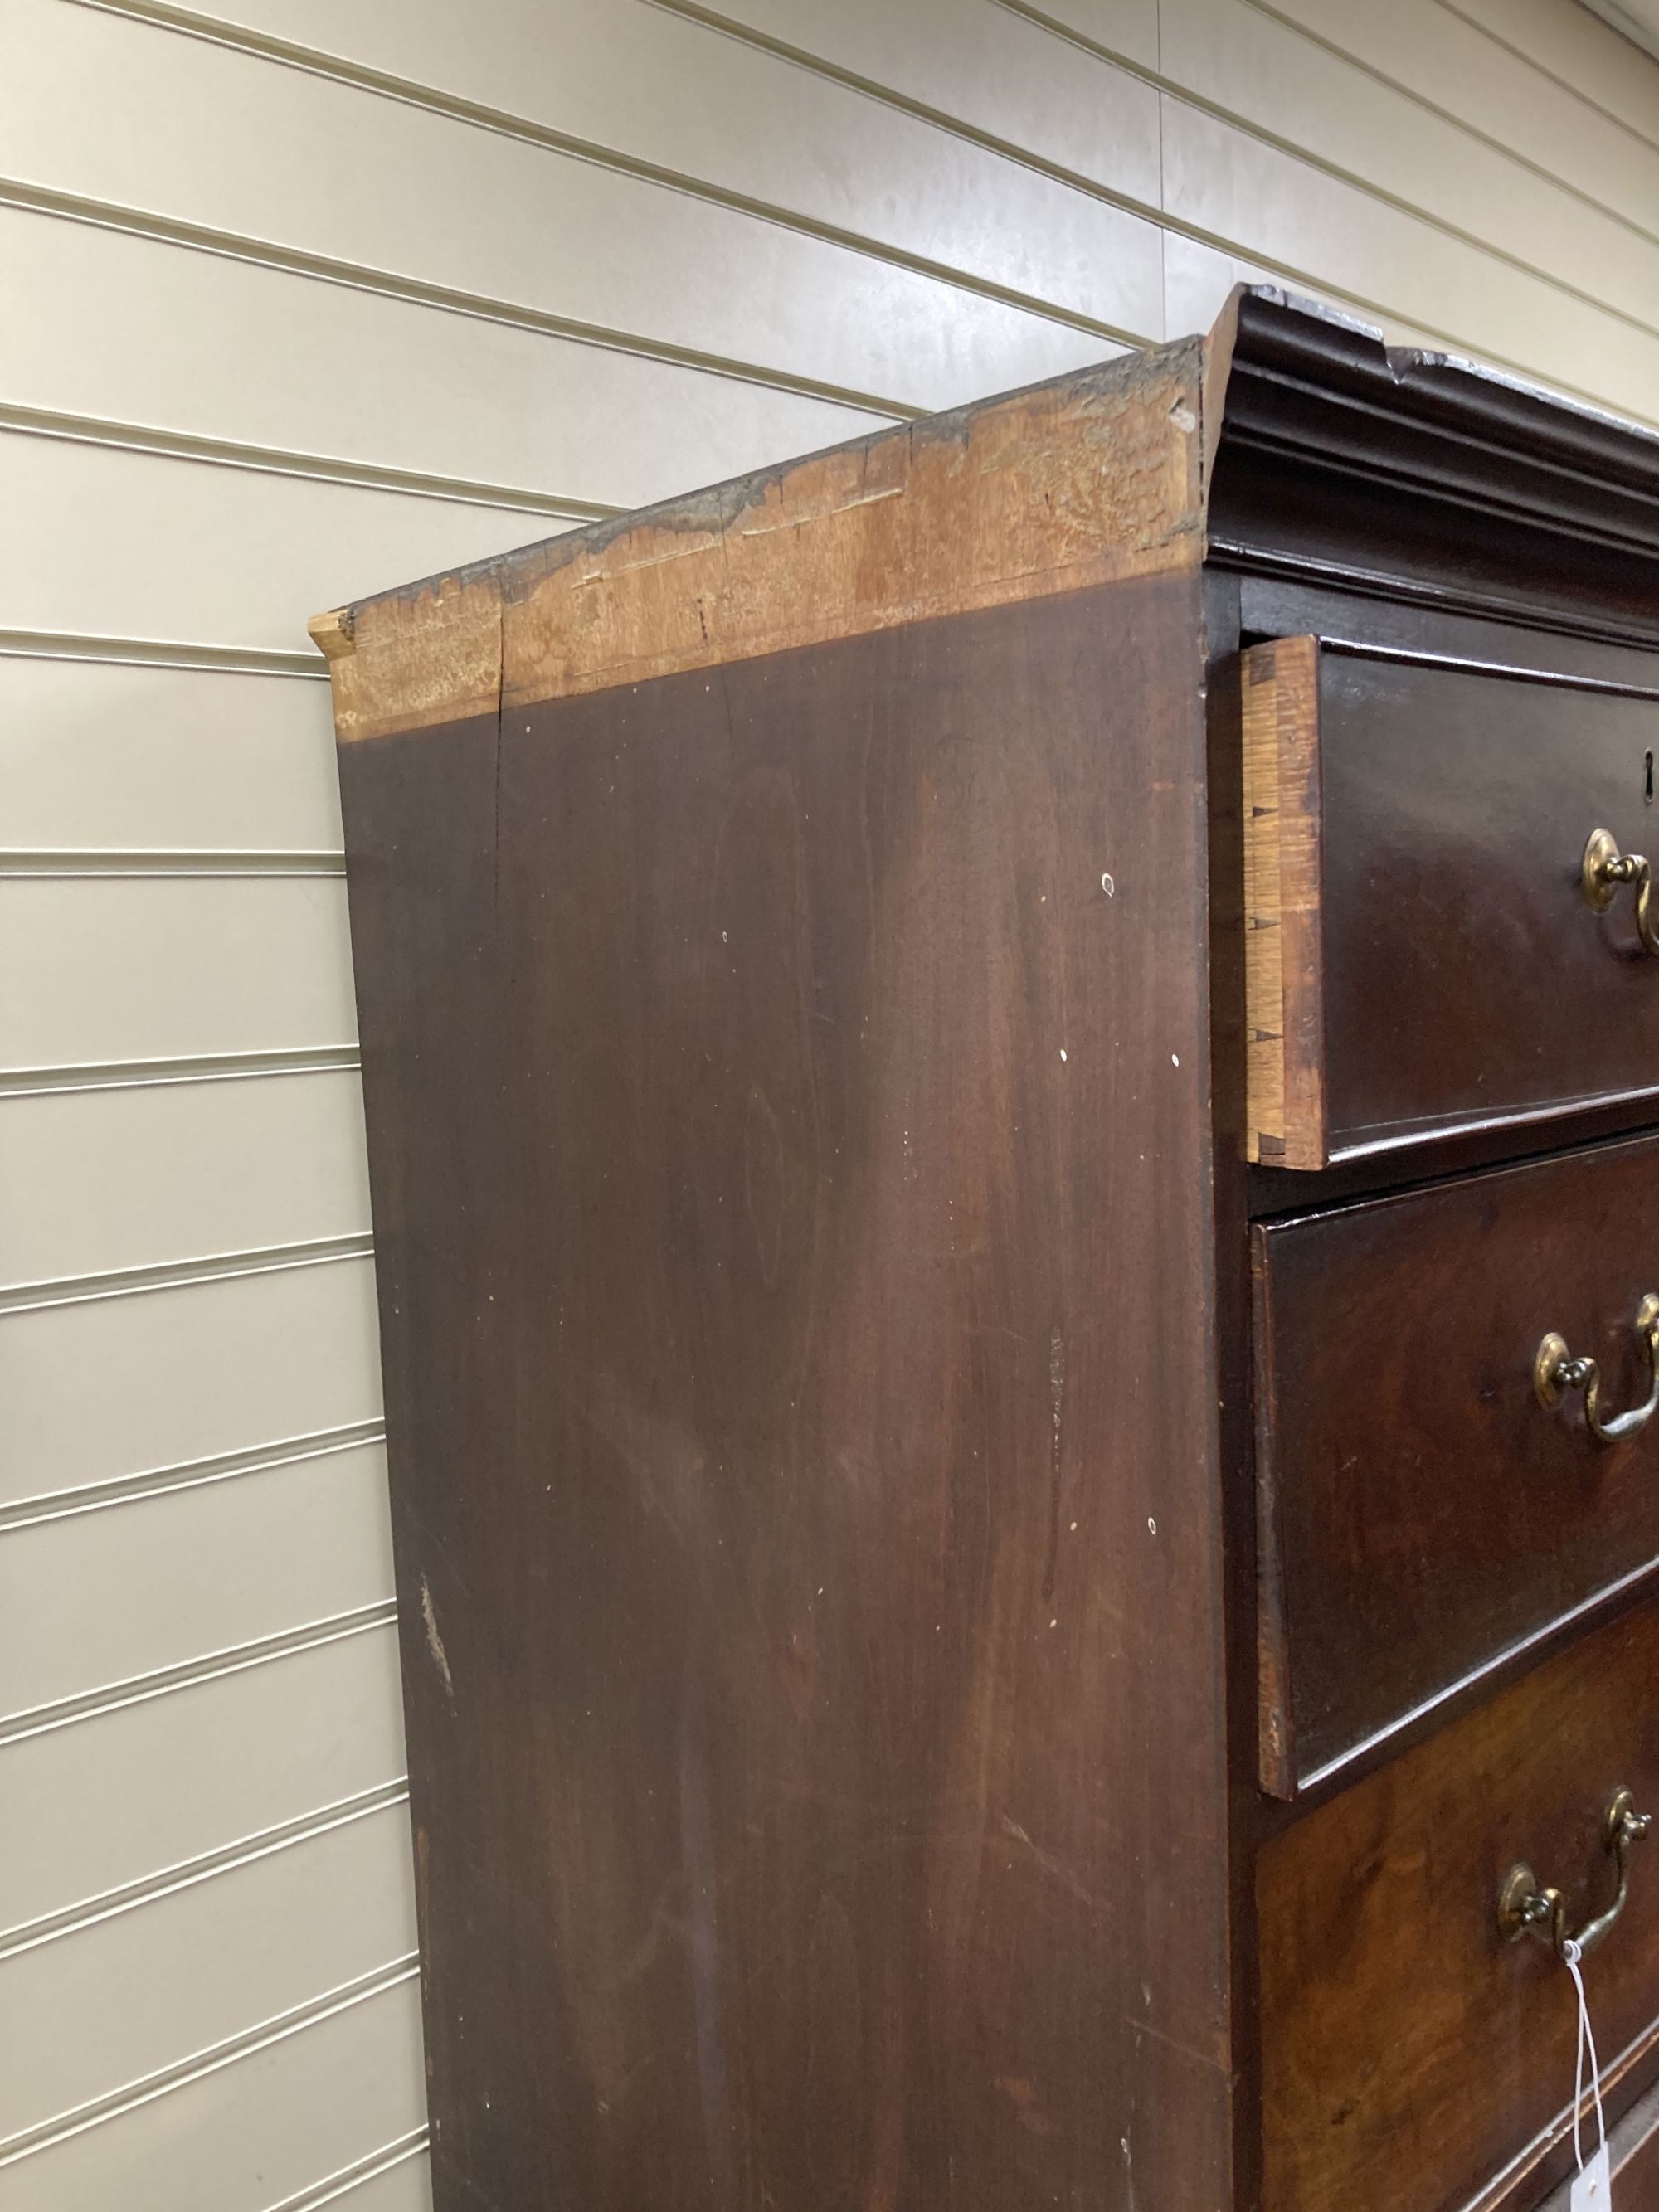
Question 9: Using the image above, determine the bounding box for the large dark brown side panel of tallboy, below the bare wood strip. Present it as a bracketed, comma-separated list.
[343, 571, 1232, 2212]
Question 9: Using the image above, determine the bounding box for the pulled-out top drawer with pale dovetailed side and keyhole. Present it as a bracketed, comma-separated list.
[1241, 637, 1659, 1168]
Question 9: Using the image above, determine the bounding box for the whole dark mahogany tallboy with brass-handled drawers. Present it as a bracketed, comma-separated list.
[314, 292, 1659, 2212]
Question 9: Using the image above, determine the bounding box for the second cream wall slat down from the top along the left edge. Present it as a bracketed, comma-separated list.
[0, 208, 892, 522]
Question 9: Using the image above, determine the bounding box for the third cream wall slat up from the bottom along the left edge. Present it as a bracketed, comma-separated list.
[0, 1621, 407, 1946]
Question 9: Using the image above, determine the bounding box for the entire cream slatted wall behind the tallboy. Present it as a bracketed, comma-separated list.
[0, 0, 1659, 2212]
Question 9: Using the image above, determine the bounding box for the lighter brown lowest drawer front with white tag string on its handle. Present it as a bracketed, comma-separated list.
[1257, 1606, 1659, 2212]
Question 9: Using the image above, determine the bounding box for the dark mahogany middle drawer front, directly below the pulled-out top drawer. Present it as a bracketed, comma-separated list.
[1254, 1132, 1659, 1796]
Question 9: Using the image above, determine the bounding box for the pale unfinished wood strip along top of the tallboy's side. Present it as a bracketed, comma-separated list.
[312, 338, 1204, 743]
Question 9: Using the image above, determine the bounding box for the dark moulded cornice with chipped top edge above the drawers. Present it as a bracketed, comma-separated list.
[1208, 289, 1659, 641]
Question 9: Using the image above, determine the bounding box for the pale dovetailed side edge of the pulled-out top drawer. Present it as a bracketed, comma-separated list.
[1243, 637, 1325, 1168]
